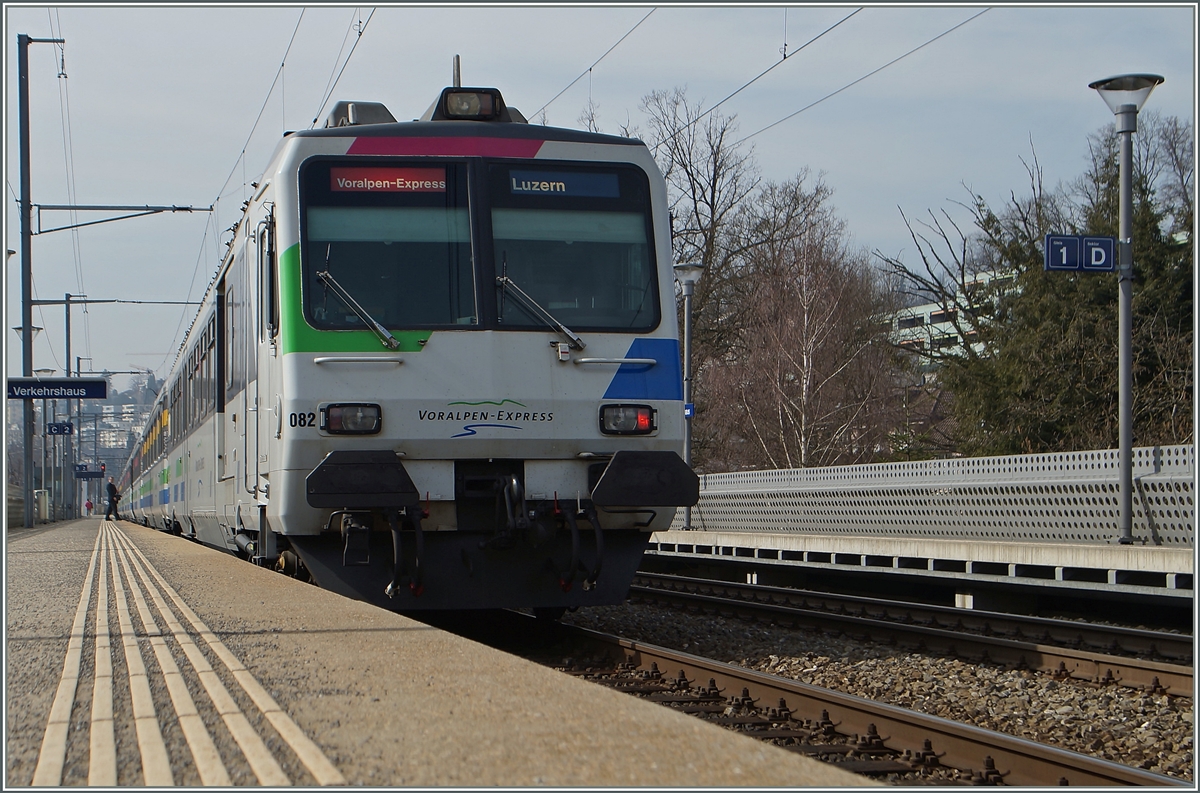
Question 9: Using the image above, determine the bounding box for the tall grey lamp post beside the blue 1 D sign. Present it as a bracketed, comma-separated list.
[1087, 74, 1163, 545]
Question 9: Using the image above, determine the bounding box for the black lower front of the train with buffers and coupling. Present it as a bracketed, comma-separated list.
[288, 450, 700, 611]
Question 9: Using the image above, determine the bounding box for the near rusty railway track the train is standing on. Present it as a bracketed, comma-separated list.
[563, 626, 1190, 787]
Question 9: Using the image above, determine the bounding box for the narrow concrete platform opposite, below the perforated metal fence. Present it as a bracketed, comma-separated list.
[642, 527, 1195, 614]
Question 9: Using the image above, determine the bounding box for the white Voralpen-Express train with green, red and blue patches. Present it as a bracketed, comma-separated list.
[119, 85, 700, 615]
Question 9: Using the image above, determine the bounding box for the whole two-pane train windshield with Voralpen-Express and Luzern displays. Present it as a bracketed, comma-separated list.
[301, 158, 660, 332]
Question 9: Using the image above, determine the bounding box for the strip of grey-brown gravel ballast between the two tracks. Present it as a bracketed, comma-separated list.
[563, 603, 1194, 781]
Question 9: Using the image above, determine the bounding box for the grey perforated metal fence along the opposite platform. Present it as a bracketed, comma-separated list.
[671, 445, 1195, 548]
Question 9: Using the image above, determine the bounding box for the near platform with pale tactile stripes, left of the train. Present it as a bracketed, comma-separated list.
[5, 518, 872, 787]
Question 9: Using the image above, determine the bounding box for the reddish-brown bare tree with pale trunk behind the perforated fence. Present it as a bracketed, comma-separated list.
[698, 173, 899, 469]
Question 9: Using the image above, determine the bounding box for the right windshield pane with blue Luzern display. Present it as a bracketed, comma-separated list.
[488, 163, 659, 331]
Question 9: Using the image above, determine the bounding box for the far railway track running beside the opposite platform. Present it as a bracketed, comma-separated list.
[630, 572, 1193, 697]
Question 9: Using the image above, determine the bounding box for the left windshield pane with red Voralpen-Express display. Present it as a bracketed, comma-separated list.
[304, 161, 479, 330]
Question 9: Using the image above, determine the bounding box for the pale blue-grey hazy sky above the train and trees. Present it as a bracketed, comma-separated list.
[4, 4, 1196, 388]
